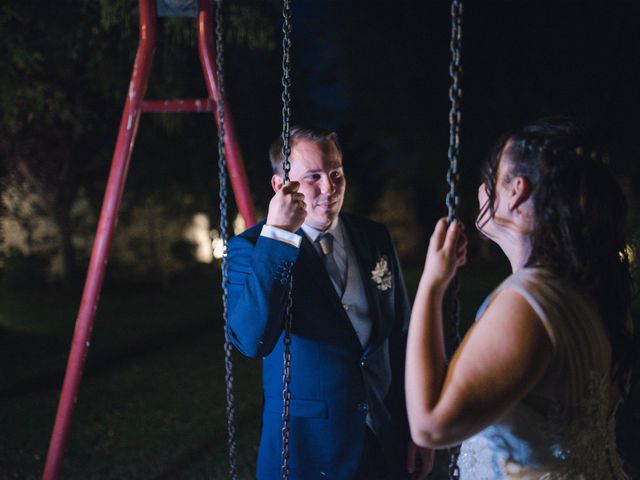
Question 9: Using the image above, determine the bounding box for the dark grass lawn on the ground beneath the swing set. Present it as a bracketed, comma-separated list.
[0, 260, 640, 480]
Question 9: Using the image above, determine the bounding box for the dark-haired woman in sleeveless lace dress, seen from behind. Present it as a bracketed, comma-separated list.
[406, 121, 633, 480]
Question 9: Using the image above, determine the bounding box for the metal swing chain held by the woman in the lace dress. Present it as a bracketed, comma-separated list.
[446, 0, 462, 480]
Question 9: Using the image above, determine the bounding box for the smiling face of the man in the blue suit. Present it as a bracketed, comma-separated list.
[272, 140, 346, 231]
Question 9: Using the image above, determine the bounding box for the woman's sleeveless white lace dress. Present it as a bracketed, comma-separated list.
[459, 268, 628, 480]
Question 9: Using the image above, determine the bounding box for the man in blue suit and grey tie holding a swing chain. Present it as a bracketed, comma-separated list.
[228, 127, 433, 480]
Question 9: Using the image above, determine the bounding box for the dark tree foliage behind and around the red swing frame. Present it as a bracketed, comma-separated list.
[0, 0, 288, 279]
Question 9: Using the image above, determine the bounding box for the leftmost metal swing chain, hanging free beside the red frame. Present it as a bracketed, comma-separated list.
[215, 0, 238, 480]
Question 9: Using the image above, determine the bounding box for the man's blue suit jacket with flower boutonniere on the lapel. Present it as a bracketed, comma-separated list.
[228, 214, 409, 480]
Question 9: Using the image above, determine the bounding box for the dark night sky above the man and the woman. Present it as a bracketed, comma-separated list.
[224, 0, 640, 221]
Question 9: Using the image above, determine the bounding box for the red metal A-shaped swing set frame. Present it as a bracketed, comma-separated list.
[42, 0, 256, 480]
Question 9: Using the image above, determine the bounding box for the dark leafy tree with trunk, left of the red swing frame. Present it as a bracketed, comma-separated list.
[0, 0, 138, 279]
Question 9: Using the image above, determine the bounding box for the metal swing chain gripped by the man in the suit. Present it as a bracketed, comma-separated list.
[281, 0, 293, 480]
